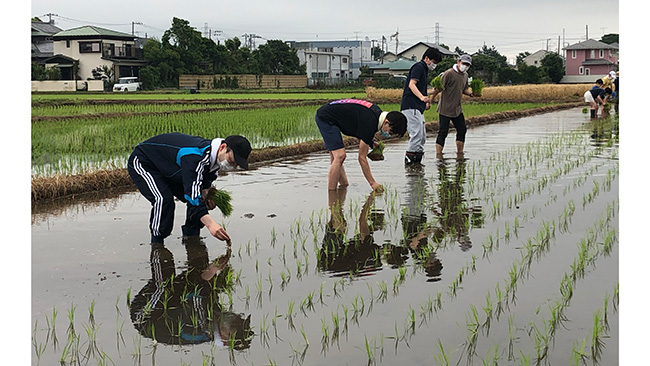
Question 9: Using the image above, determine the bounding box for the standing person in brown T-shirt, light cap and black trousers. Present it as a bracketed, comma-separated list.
[431, 54, 474, 157]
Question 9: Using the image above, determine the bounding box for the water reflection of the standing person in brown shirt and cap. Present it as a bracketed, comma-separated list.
[434, 155, 481, 252]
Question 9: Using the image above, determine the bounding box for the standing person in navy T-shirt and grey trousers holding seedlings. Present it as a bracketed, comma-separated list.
[400, 47, 442, 165]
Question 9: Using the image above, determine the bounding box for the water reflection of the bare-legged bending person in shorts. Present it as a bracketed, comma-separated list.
[318, 188, 381, 276]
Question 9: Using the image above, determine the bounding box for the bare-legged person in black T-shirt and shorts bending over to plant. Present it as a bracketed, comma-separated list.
[316, 99, 406, 191]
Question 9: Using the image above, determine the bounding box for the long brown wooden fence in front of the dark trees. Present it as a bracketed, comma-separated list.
[178, 74, 307, 90]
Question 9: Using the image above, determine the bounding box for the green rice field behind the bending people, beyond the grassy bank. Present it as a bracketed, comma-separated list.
[31, 94, 547, 177]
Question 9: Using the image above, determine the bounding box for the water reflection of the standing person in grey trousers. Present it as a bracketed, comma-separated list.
[392, 165, 442, 282]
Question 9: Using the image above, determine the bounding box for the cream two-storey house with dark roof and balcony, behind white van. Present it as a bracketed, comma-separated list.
[45, 25, 146, 80]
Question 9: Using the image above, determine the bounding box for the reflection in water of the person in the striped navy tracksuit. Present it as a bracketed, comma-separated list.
[130, 236, 253, 349]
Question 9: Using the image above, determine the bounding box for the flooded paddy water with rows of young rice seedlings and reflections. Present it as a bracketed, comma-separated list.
[31, 109, 619, 365]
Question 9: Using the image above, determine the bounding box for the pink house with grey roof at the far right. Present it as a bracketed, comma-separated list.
[560, 39, 618, 83]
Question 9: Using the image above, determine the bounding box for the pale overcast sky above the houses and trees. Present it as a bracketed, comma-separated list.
[30, 0, 619, 61]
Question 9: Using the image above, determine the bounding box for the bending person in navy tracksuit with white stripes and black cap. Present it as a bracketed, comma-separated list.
[128, 133, 251, 244]
